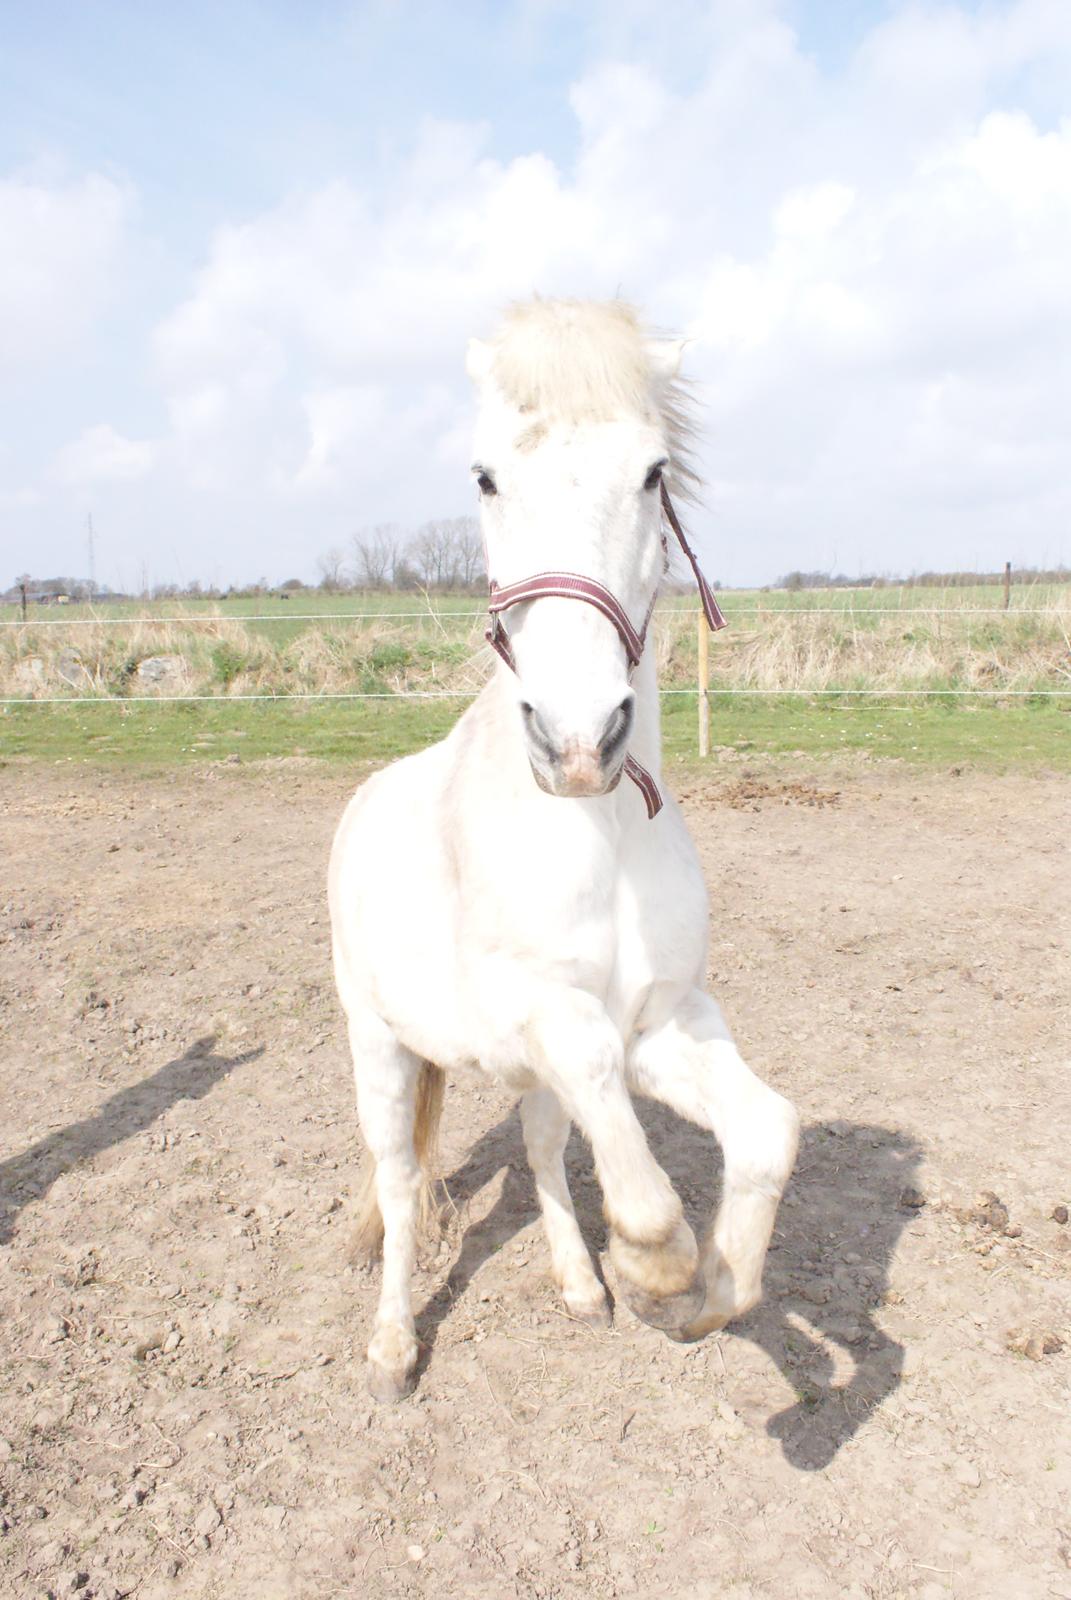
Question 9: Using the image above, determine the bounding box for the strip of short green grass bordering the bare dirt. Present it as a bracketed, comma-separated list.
[0, 694, 1071, 773]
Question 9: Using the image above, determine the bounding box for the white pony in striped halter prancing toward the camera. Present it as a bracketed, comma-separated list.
[328, 299, 799, 1400]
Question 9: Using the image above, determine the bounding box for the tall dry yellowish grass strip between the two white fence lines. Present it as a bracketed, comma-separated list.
[0, 590, 1071, 699]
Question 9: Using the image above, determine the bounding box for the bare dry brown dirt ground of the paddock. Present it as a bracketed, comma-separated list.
[0, 762, 1071, 1600]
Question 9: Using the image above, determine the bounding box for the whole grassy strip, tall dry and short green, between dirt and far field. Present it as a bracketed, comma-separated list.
[0, 584, 1071, 771]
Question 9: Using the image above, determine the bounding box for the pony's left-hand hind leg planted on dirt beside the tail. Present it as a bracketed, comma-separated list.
[349, 1016, 442, 1402]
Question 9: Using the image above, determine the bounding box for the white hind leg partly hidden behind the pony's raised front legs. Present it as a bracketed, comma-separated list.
[520, 1088, 610, 1328]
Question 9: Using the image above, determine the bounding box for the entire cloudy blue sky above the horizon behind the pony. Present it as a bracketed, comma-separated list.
[0, 0, 1071, 587]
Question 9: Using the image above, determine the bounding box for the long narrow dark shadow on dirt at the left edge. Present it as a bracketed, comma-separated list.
[0, 1035, 264, 1245]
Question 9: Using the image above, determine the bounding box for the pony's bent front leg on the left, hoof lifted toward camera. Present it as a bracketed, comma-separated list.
[527, 986, 706, 1333]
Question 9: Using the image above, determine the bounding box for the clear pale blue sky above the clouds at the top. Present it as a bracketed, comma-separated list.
[0, 0, 915, 272]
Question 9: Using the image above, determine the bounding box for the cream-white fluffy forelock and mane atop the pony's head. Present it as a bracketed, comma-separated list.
[491, 296, 698, 496]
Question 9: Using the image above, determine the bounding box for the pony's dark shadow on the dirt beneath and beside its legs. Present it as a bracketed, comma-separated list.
[416, 1102, 922, 1472]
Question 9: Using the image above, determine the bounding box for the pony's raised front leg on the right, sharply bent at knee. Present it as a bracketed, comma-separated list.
[628, 990, 799, 1339]
